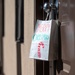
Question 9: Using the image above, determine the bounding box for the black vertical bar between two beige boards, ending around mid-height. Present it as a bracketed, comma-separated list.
[15, 0, 24, 43]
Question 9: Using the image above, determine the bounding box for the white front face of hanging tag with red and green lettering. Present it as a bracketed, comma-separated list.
[29, 20, 52, 60]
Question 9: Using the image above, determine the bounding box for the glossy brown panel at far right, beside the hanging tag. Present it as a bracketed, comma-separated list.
[59, 0, 75, 75]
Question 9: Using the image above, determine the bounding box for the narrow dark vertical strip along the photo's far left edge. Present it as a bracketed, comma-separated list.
[0, 0, 4, 75]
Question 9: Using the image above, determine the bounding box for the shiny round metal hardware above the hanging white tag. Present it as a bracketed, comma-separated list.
[43, 0, 59, 20]
